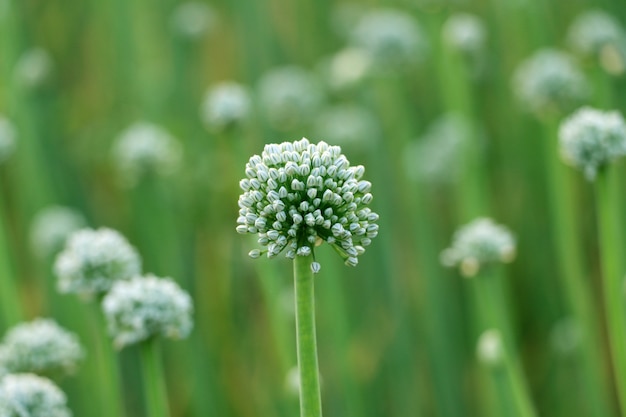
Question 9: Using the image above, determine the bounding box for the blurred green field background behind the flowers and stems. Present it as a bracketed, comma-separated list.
[0, 0, 626, 417]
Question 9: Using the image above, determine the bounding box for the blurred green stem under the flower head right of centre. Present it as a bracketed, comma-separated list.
[469, 266, 537, 417]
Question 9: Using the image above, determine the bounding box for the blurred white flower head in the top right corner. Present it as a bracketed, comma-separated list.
[567, 10, 626, 74]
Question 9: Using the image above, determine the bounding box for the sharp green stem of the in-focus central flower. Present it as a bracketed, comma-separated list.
[293, 255, 322, 417]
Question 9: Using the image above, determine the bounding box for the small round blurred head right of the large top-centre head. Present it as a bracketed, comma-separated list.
[442, 13, 487, 55]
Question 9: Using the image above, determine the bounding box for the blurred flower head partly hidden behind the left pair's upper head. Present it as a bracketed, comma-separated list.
[30, 206, 86, 258]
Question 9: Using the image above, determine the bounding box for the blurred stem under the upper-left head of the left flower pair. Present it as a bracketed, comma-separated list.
[88, 299, 126, 417]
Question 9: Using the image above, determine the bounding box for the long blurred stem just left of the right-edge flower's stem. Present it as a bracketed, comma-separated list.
[541, 118, 613, 416]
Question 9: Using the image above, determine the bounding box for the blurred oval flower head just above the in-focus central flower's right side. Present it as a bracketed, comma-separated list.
[314, 104, 381, 150]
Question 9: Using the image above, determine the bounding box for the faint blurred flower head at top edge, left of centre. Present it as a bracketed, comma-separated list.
[171, 1, 217, 40]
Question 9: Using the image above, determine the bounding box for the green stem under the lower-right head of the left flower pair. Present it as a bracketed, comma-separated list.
[140, 338, 170, 417]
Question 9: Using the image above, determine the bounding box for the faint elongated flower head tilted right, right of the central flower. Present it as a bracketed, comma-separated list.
[404, 113, 470, 184]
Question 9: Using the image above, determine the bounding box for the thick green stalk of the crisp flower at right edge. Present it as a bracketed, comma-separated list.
[596, 166, 626, 416]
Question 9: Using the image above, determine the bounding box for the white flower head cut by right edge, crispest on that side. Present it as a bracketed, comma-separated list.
[559, 107, 626, 180]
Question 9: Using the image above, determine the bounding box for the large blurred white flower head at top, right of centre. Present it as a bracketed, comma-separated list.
[350, 9, 428, 72]
